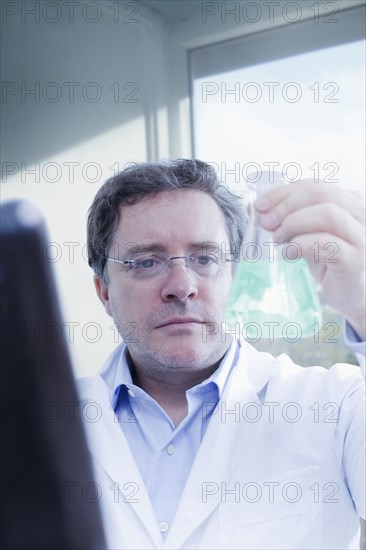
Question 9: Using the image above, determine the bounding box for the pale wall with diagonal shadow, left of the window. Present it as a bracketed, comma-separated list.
[1, 1, 169, 376]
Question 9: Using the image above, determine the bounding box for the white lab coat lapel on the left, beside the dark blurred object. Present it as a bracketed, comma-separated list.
[84, 376, 162, 547]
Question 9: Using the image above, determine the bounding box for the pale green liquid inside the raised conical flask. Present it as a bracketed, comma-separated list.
[224, 259, 321, 338]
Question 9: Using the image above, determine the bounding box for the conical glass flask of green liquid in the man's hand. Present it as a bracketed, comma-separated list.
[224, 171, 321, 342]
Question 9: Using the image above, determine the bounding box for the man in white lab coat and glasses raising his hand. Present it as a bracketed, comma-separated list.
[81, 160, 365, 549]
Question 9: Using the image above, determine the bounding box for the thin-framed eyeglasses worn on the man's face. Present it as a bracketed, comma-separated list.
[106, 252, 236, 279]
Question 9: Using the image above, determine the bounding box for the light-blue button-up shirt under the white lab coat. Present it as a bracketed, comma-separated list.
[111, 343, 237, 534]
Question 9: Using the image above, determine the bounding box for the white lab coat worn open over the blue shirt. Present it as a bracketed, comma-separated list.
[76, 343, 365, 550]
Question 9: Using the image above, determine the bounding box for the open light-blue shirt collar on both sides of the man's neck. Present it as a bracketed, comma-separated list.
[108, 341, 240, 410]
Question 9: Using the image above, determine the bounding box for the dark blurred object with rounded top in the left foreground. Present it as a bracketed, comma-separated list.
[0, 201, 105, 550]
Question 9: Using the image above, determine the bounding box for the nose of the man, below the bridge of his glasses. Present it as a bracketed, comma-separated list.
[161, 258, 198, 302]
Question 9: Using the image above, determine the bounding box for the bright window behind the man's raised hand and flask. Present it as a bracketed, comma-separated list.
[190, 8, 365, 364]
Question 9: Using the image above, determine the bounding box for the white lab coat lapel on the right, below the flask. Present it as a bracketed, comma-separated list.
[164, 343, 273, 549]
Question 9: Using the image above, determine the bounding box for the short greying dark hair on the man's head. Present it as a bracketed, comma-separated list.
[87, 159, 246, 281]
